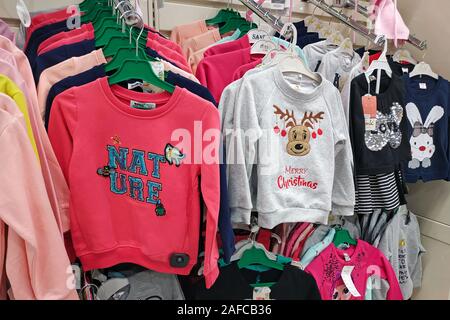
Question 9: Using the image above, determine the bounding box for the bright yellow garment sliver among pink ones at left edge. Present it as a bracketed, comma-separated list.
[0, 74, 39, 160]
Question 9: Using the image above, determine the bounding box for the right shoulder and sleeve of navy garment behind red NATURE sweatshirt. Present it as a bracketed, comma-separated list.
[166, 71, 235, 263]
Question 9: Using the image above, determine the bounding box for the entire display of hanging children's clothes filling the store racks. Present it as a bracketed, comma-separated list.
[0, 0, 449, 300]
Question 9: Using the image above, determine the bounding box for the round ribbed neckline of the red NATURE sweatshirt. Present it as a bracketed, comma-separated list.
[99, 77, 185, 119]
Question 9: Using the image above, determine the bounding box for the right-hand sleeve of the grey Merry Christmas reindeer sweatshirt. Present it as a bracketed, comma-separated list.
[329, 87, 355, 216]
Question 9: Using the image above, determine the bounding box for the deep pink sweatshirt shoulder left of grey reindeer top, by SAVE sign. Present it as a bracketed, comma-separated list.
[195, 47, 261, 101]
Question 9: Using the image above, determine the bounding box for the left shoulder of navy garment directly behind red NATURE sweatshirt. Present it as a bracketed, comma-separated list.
[44, 64, 106, 129]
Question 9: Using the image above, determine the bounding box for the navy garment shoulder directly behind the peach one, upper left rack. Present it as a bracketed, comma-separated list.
[33, 40, 95, 84]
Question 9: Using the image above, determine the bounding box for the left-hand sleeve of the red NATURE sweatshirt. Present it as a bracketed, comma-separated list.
[48, 88, 77, 181]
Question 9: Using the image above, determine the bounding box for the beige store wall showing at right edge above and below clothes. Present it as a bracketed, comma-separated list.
[398, 0, 450, 299]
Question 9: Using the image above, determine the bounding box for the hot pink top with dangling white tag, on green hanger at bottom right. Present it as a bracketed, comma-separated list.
[306, 240, 403, 300]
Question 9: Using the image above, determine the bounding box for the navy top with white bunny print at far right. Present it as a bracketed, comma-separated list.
[403, 75, 450, 183]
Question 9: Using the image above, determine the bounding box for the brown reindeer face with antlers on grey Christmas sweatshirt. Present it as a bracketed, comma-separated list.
[273, 105, 325, 157]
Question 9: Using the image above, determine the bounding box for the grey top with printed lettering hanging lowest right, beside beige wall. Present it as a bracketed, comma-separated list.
[374, 206, 425, 300]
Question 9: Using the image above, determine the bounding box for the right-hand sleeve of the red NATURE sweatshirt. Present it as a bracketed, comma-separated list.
[200, 105, 220, 288]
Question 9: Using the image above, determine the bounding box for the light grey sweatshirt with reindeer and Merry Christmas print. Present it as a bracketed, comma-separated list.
[222, 67, 355, 229]
